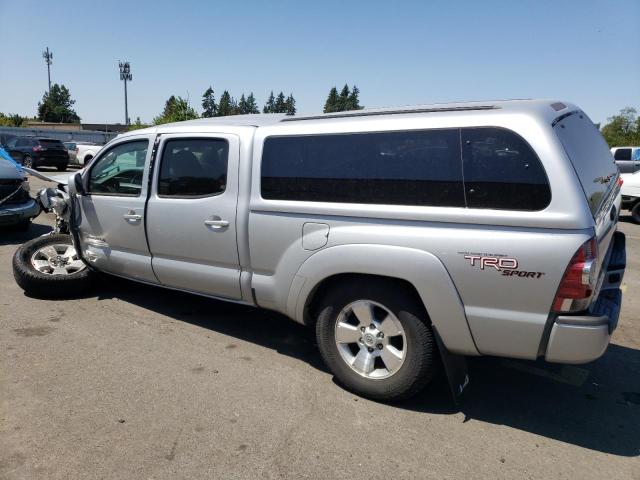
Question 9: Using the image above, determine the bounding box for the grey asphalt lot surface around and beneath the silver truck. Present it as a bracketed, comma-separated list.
[0, 171, 640, 479]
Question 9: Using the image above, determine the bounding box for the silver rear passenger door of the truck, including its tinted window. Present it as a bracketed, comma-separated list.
[147, 134, 241, 299]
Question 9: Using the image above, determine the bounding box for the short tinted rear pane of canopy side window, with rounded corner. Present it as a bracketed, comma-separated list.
[462, 128, 551, 211]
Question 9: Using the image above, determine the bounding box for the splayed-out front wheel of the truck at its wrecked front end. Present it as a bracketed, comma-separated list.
[13, 234, 92, 298]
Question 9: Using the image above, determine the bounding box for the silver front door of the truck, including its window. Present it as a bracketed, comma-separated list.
[73, 135, 157, 283]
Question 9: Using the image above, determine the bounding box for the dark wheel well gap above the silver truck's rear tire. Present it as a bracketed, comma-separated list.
[303, 273, 427, 326]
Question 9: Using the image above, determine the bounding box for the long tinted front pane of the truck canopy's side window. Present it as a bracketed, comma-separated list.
[261, 129, 465, 207]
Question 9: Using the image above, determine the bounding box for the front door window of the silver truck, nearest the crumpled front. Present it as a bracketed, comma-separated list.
[89, 140, 149, 196]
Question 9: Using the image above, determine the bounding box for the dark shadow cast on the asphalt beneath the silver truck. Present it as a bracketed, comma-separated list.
[53, 277, 640, 457]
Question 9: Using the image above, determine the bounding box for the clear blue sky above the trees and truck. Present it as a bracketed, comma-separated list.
[0, 0, 640, 123]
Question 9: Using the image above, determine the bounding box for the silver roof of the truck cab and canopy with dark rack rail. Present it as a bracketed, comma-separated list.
[116, 99, 576, 135]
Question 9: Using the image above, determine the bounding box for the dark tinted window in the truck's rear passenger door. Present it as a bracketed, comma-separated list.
[158, 138, 229, 197]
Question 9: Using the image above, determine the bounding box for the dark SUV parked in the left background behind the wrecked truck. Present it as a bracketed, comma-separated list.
[7, 137, 69, 172]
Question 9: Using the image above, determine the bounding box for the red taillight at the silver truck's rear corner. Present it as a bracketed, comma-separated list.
[552, 237, 598, 313]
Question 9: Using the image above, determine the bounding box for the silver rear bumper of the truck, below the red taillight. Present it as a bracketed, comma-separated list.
[545, 232, 626, 364]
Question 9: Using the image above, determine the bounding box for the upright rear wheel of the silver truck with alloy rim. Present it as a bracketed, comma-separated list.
[316, 280, 437, 401]
